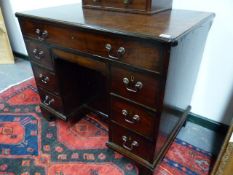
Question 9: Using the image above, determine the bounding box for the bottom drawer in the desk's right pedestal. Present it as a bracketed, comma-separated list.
[109, 122, 155, 162]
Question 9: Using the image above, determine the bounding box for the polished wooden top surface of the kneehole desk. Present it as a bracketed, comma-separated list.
[16, 4, 214, 42]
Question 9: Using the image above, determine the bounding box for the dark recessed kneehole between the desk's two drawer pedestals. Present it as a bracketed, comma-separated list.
[54, 51, 107, 114]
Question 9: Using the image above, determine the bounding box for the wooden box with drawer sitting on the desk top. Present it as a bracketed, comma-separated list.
[82, 0, 172, 14]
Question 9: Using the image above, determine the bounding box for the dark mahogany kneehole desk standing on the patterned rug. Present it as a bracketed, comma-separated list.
[16, 4, 214, 175]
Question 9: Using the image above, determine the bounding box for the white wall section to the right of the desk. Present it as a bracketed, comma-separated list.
[173, 0, 233, 124]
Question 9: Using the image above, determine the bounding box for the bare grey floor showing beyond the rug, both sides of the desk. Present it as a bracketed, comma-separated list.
[0, 59, 224, 155]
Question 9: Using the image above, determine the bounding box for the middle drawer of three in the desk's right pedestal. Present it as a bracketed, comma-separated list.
[111, 96, 159, 139]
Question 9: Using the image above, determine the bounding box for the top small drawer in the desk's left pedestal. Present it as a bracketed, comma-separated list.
[25, 40, 53, 70]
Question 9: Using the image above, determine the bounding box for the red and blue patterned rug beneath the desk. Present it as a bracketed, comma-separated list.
[0, 79, 214, 175]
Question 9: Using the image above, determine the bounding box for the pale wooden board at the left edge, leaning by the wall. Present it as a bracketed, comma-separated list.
[0, 8, 14, 64]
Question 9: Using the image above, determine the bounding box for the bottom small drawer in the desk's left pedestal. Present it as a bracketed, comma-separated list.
[38, 88, 64, 112]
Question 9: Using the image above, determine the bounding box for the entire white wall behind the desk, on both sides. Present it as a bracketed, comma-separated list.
[0, 0, 233, 124]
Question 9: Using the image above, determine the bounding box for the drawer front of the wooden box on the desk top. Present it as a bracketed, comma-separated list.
[83, 0, 146, 11]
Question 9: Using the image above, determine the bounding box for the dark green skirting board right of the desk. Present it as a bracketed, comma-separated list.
[187, 113, 229, 135]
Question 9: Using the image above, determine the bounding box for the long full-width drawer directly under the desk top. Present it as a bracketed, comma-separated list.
[20, 19, 163, 72]
